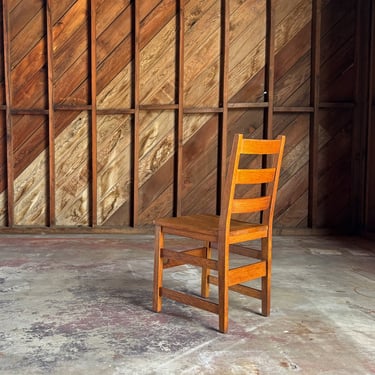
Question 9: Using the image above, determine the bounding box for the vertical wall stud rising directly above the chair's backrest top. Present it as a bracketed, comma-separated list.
[263, 0, 275, 139]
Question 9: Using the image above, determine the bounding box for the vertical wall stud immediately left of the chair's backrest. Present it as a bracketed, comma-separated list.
[216, 0, 230, 214]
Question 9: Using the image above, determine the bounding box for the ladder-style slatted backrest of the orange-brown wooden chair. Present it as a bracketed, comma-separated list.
[220, 134, 285, 231]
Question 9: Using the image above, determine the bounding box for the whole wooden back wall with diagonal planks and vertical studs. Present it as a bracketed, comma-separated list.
[0, 0, 368, 231]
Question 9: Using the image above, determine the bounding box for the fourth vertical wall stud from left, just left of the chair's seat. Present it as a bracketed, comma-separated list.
[132, 0, 140, 226]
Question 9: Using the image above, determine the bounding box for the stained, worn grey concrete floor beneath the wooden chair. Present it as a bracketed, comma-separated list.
[0, 235, 375, 375]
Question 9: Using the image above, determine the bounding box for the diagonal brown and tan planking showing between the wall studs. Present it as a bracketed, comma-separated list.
[0, 0, 358, 227]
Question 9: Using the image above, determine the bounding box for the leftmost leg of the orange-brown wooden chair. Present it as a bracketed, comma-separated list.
[153, 225, 164, 312]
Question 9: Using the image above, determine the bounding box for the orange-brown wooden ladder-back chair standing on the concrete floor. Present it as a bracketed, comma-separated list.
[153, 134, 285, 333]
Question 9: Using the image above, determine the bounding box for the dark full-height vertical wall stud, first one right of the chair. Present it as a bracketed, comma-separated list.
[308, 0, 322, 228]
